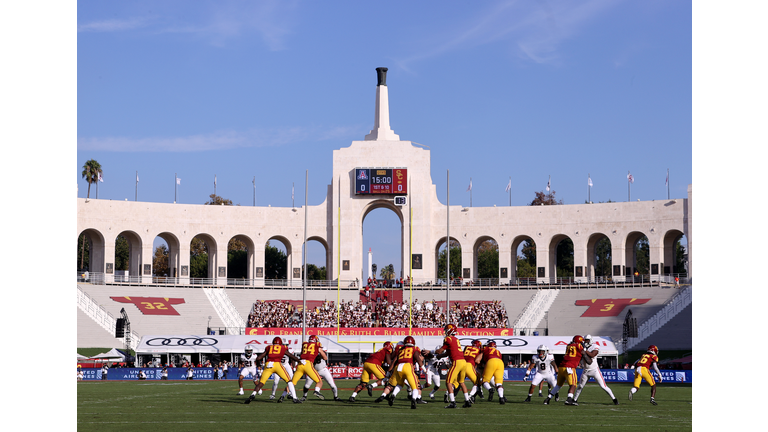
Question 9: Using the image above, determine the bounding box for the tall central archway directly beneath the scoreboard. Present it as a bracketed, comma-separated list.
[364, 200, 410, 288]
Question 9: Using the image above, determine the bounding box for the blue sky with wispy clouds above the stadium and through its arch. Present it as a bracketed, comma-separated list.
[73, 0, 693, 271]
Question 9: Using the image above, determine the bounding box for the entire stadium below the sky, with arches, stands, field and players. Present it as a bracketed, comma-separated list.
[77, 63, 693, 430]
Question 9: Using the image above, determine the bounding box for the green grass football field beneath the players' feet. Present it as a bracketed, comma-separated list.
[77, 380, 693, 432]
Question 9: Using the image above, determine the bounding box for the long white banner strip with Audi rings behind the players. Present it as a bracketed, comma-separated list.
[136, 329, 618, 356]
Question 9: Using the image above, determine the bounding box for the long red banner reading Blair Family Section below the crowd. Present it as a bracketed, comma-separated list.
[245, 327, 514, 336]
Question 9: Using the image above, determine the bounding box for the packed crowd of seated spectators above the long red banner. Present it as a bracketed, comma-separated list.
[248, 300, 509, 328]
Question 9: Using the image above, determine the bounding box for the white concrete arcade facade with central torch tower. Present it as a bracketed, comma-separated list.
[77, 68, 693, 287]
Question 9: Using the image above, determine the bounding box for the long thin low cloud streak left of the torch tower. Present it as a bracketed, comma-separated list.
[77, 127, 365, 152]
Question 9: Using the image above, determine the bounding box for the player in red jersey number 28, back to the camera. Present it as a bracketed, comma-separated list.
[375, 336, 424, 409]
